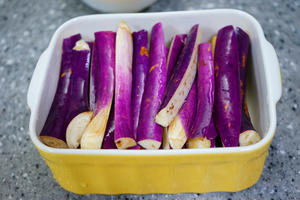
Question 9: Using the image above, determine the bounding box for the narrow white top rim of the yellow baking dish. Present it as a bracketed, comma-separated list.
[27, 9, 281, 156]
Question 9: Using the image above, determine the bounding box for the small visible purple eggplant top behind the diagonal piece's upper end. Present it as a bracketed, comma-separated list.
[167, 34, 187, 81]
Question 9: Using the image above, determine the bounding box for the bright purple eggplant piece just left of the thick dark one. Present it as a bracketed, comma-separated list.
[187, 43, 217, 148]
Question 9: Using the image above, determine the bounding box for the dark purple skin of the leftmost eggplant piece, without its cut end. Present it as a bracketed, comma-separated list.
[40, 34, 81, 144]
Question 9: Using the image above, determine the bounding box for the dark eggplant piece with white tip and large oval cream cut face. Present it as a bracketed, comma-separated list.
[58, 40, 91, 148]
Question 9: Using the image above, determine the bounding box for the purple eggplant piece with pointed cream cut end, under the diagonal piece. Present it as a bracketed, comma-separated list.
[168, 81, 197, 149]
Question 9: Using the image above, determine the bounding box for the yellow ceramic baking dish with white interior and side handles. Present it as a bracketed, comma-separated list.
[27, 9, 282, 194]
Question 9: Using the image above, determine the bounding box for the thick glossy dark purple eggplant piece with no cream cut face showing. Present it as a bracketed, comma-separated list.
[213, 26, 241, 147]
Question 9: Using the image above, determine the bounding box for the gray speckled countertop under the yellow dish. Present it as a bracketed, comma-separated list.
[0, 0, 300, 200]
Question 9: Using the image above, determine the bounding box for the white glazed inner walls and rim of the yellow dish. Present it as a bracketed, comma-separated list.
[28, 9, 278, 155]
